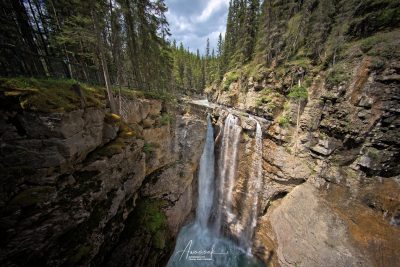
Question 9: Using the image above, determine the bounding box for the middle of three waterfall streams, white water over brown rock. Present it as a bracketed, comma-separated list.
[214, 114, 242, 234]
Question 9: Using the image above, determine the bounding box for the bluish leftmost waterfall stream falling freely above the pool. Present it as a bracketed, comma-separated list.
[196, 115, 215, 228]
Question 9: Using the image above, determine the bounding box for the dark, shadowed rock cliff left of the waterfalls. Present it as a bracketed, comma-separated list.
[0, 93, 206, 266]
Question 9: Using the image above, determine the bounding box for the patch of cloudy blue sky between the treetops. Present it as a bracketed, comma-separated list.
[165, 0, 229, 54]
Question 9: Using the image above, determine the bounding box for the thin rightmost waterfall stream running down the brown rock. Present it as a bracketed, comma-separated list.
[239, 119, 263, 254]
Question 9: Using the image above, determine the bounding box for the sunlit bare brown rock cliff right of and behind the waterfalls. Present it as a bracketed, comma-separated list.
[209, 56, 400, 266]
